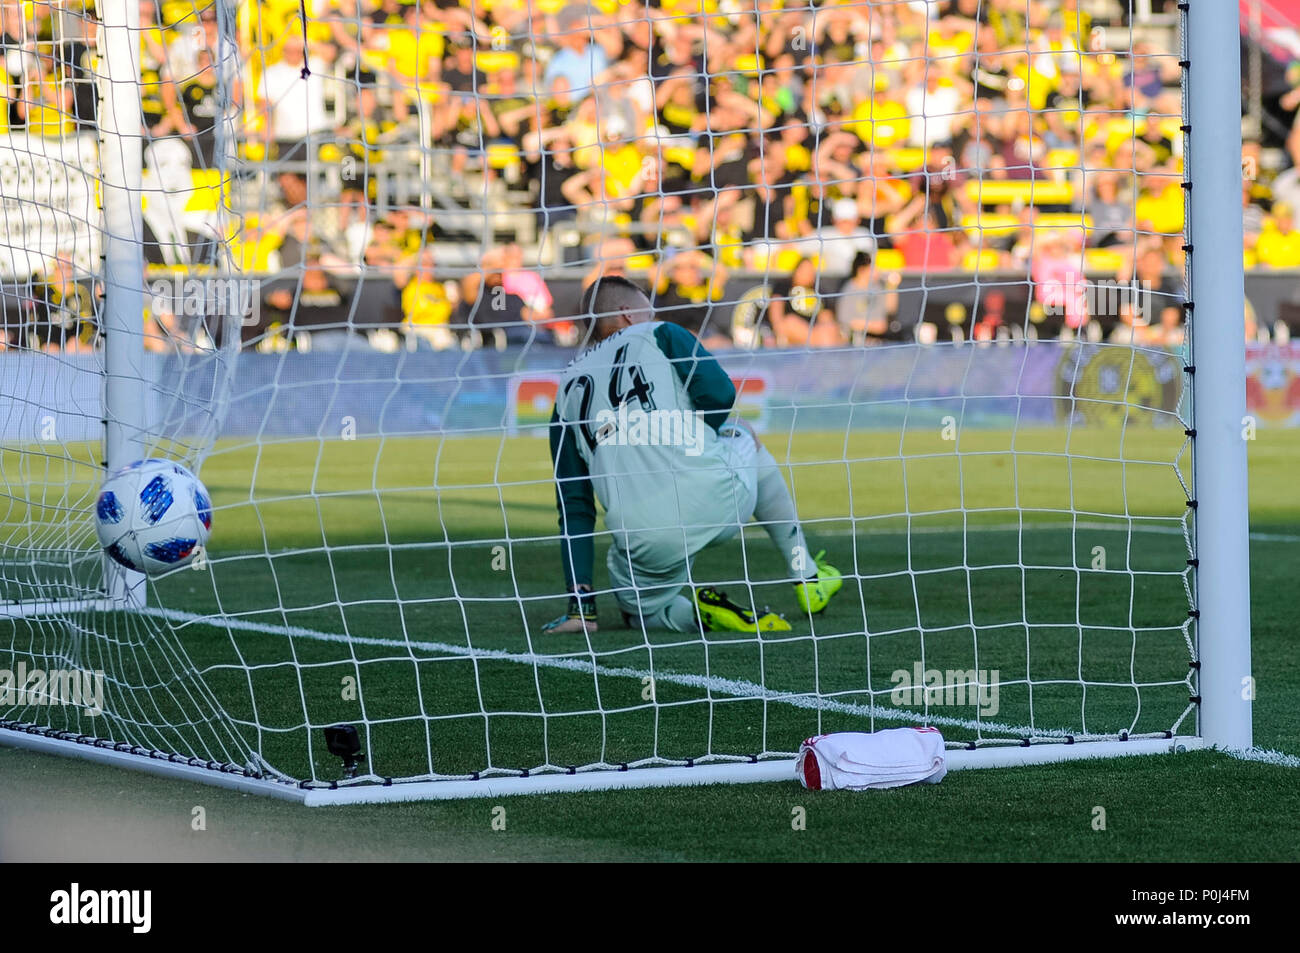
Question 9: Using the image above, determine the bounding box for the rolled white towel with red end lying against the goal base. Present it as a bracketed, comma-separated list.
[794, 728, 948, 790]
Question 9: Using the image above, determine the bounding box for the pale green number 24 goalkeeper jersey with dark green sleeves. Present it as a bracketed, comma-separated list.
[550, 321, 736, 590]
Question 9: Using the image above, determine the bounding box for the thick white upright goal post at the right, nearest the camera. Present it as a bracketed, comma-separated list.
[1184, 0, 1255, 749]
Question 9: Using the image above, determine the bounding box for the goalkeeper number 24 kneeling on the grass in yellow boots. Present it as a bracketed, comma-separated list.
[542, 276, 842, 632]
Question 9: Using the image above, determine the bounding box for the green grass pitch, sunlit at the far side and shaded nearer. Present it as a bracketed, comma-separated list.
[0, 426, 1300, 859]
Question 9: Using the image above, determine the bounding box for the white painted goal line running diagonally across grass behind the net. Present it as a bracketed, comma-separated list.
[139, 608, 1069, 738]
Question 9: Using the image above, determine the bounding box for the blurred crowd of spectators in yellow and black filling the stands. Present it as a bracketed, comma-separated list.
[0, 0, 1300, 348]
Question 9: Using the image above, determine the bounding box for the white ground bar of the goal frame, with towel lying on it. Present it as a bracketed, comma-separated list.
[0, 728, 1206, 807]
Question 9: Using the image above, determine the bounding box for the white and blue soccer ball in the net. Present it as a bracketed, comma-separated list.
[95, 460, 212, 576]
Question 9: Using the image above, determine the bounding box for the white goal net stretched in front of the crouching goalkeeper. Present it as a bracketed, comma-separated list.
[0, 0, 1248, 800]
